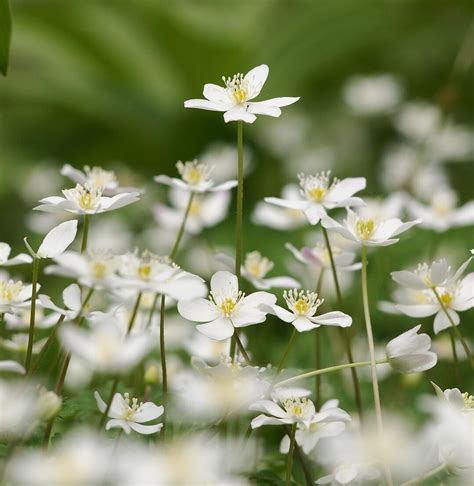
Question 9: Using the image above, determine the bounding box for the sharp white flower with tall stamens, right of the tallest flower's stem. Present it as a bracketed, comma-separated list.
[265, 171, 366, 225]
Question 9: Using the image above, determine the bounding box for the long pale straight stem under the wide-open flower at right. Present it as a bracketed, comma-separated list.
[362, 245, 393, 486]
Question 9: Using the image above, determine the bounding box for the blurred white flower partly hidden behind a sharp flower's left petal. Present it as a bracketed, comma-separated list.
[252, 184, 307, 231]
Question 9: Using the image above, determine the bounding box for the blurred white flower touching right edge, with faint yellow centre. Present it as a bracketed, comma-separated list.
[407, 189, 474, 233]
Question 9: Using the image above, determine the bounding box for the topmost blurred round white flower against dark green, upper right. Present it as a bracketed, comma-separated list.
[344, 74, 402, 115]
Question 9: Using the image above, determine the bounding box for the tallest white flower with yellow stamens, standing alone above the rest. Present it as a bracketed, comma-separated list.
[184, 64, 299, 123]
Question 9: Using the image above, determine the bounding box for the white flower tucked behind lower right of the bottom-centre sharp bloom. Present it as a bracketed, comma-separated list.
[280, 400, 351, 454]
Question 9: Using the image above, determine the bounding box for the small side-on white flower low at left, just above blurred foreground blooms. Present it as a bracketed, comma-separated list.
[94, 392, 165, 435]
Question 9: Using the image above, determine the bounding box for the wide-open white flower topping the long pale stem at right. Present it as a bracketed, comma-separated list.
[322, 209, 420, 246]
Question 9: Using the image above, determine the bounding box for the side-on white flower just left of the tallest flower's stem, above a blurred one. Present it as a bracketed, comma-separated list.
[154, 160, 237, 192]
